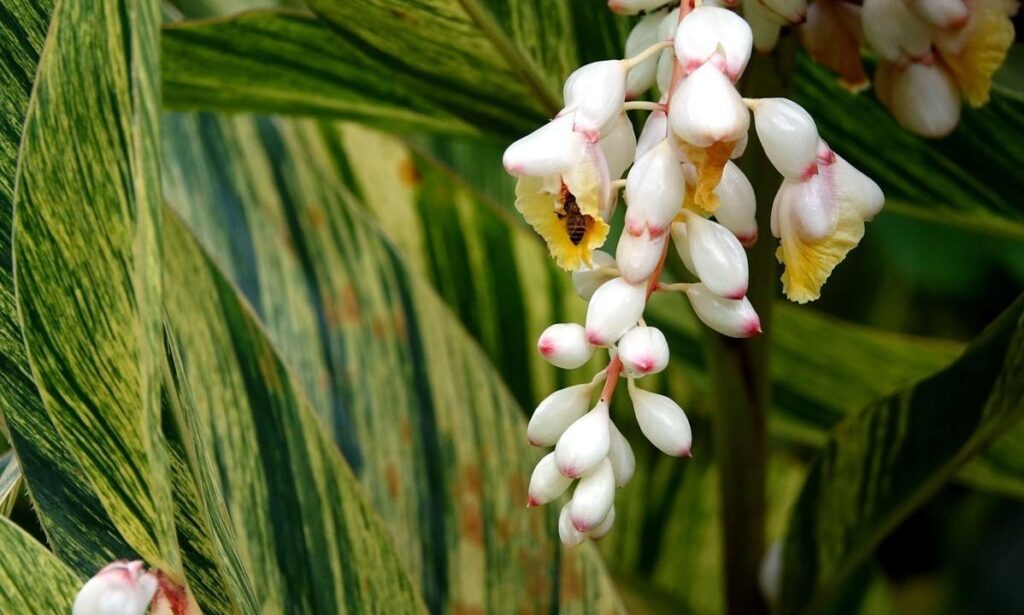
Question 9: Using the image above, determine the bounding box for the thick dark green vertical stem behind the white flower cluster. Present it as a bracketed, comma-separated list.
[708, 37, 796, 615]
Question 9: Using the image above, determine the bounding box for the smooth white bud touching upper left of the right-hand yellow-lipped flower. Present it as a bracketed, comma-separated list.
[754, 98, 818, 179]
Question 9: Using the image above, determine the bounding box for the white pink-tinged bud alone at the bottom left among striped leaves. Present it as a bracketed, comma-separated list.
[72, 561, 159, 615]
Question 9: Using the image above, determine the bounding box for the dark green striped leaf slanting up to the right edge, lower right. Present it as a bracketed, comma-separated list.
[780, 298, 1024, 613]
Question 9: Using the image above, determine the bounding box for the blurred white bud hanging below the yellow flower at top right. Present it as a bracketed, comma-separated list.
[889, 62, 961, 138]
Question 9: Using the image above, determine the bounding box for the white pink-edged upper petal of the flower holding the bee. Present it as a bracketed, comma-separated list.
[502, 114, 587, 177]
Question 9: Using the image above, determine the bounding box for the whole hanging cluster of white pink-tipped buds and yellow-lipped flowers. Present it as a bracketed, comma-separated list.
[504, 0, 882, 544]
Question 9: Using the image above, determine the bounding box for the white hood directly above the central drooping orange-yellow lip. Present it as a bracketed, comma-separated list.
[669, 62, 751, 147]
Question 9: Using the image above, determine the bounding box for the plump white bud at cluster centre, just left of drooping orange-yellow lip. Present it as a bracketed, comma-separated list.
[620, 139, 686, 236]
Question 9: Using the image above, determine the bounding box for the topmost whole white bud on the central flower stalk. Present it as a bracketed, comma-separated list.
[675, 6, 754, 81]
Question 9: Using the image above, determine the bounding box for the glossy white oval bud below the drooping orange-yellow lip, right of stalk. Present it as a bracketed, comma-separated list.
[683, 211, 748, 299]
